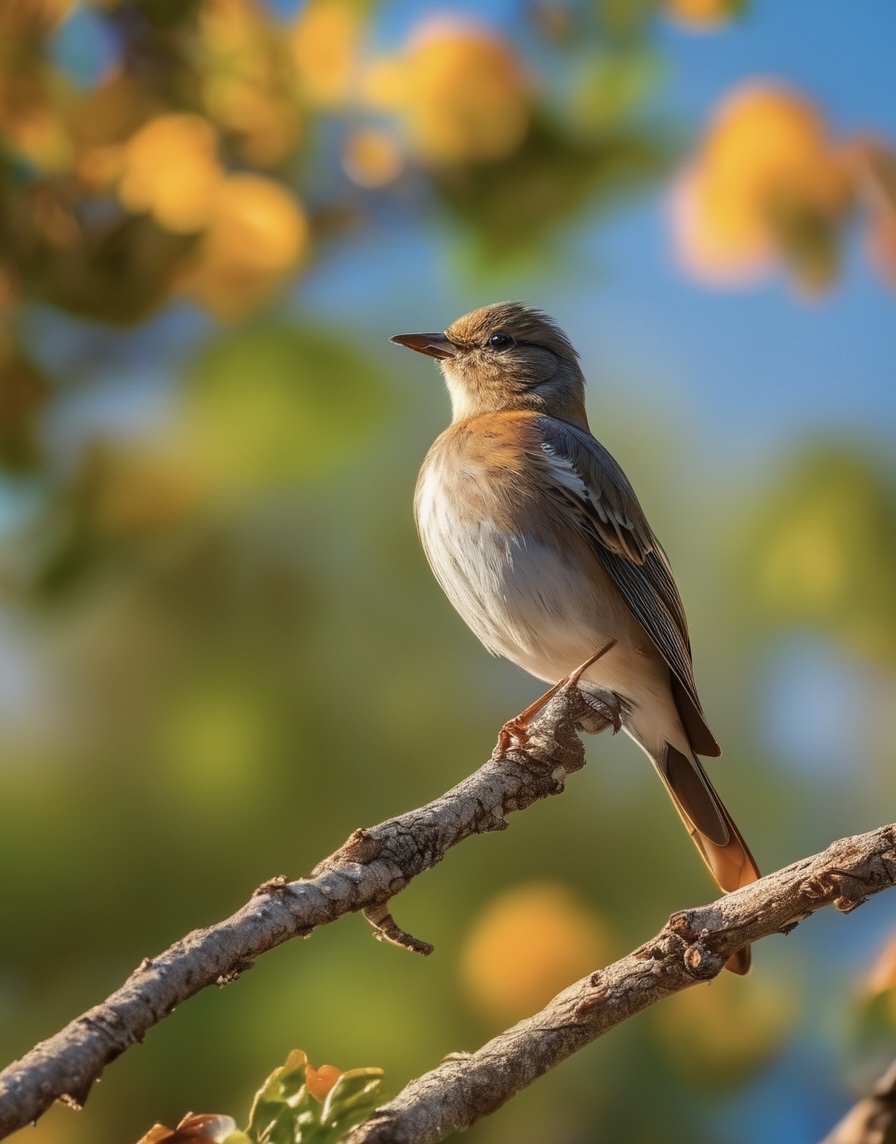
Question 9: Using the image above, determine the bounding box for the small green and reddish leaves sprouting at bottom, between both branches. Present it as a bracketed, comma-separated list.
[140, 1049, 382, 1144]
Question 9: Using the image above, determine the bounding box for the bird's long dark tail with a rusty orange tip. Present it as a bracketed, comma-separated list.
[650, 742, 760, 974]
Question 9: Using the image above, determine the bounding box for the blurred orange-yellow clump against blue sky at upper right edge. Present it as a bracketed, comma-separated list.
[673, 81, 896, 291]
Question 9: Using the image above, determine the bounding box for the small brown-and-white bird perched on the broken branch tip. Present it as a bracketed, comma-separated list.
[391, 302, 760, 974]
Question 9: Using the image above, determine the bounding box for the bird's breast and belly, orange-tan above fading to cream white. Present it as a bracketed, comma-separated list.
[415, 426, 629, 681]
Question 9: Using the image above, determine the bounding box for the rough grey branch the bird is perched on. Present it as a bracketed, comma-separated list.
[0, 689, 593, 1138]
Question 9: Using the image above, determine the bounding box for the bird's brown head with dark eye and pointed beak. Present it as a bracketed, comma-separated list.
[391, 302, 587, 426]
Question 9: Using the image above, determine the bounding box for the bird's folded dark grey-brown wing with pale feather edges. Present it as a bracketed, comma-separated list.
[538, 416, 720, 756]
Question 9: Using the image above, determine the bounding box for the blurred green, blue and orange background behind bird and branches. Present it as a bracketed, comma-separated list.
[0, 0, 896, 1144]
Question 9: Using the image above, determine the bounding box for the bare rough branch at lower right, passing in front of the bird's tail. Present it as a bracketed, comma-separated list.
[344, 824, 896, 1144]
